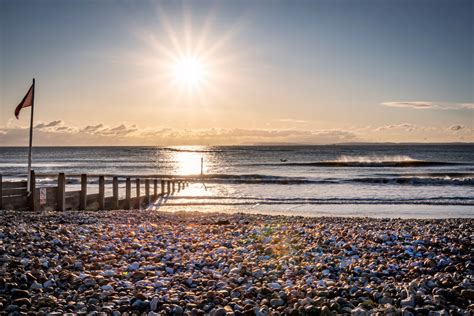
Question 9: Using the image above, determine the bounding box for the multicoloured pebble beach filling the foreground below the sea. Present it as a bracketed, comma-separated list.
[0, 210, 474, 316]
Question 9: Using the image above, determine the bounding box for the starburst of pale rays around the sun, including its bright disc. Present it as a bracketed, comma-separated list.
[129, 3, 243, 106]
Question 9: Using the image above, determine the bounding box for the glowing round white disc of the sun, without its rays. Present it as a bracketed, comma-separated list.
[172, 56, 207, 88]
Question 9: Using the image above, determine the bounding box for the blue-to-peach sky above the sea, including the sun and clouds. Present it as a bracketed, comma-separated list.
[0, 0, 474, 146]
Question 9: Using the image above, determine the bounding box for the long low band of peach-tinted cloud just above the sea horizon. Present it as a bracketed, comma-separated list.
[0, 120, 473, 146]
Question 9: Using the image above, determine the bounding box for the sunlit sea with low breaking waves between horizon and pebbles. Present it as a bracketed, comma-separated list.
[0, 144, 474, 218]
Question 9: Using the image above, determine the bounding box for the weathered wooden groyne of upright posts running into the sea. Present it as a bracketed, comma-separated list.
[0, 170, 189, 211]
